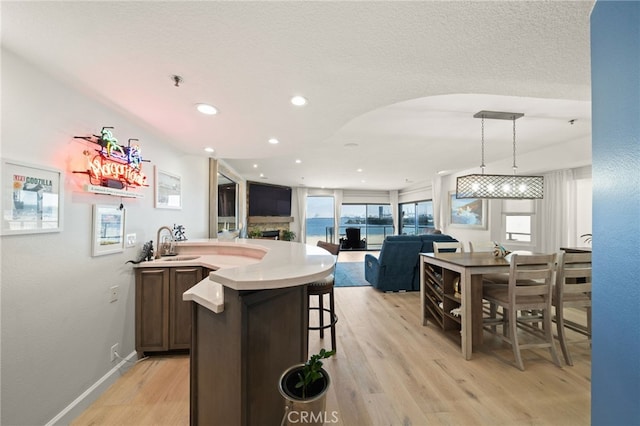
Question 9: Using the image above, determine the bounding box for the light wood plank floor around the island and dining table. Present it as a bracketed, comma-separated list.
[73, 253, 591, 426]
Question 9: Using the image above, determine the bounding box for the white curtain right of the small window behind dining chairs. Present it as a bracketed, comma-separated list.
[537, 170, 575, 253]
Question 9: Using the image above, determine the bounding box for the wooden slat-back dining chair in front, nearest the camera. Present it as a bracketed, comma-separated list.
[483, 253, 560, 371]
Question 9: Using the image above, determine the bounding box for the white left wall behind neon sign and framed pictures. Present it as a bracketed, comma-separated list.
[0, 50, 208, 425]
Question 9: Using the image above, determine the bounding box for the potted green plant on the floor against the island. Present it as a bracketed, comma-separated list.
[278, 348, 336, 425]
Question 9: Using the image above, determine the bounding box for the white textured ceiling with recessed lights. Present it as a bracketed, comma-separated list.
[1, 1, 593, 189]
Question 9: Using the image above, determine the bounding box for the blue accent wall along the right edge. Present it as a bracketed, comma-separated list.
[591, 1, 640, 425]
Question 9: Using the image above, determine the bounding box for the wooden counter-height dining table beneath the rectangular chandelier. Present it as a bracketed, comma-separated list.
[420, 252, 509, 360]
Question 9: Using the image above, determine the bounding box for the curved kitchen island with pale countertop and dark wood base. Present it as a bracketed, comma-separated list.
[139, 239, 335, 425]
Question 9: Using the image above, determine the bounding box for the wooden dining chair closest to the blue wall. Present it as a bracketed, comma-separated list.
[551, 253, 591, 365]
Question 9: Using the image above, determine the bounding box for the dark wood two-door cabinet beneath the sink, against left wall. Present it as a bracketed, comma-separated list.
[136, 266, 209, 356]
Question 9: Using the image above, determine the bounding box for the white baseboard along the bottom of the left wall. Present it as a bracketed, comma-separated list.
[45, 351, 138, 426]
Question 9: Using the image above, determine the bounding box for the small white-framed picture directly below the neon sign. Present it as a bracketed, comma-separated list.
[91, 204, 125, 256]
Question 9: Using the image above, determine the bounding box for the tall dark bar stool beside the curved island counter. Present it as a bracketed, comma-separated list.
[307, 241, 340, 351]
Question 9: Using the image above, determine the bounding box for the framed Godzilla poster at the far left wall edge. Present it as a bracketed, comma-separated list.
[0, 159, 64, 235]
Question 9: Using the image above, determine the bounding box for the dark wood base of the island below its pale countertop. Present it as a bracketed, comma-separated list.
[190, 285, 308, 426]
